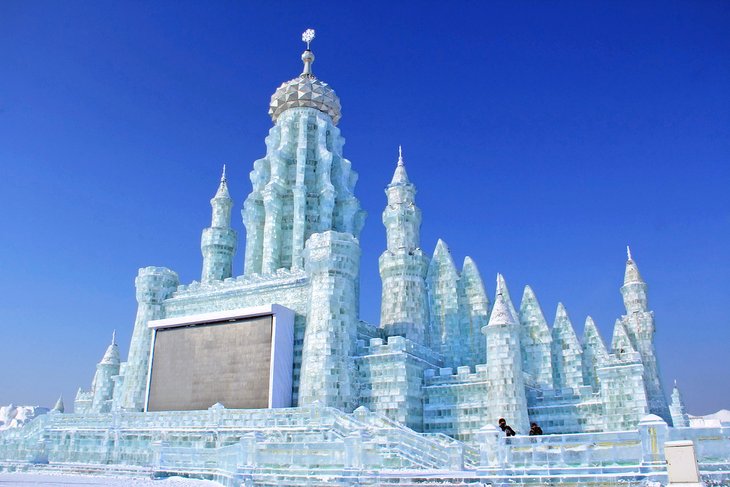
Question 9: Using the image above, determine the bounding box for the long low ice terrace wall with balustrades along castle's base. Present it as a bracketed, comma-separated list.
[0, 404, 730, 486]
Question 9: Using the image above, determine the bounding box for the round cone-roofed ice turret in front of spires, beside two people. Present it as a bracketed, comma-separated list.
[482, 283, 529, 434]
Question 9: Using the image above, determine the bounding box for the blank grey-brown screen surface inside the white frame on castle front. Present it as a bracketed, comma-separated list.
[147, 315, 273, 411]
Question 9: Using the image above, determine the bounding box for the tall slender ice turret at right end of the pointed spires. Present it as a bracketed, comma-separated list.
[621, 247, 671, 423]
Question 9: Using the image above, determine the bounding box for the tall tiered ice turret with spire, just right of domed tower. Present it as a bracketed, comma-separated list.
[379, 147, 428, 345]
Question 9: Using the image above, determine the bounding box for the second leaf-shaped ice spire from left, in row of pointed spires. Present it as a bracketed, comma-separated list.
[459, 256, 489, 365]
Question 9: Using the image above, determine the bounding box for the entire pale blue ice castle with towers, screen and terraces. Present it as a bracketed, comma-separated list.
[0, 31, 730, 485]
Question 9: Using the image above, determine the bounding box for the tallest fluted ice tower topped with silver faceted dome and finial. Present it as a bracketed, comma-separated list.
[242, 30, 365, 275]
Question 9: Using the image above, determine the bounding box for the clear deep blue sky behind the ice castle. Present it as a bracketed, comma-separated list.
[0, 0, 730, 414]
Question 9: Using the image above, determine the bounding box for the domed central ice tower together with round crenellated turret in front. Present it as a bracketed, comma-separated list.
[242, 29, 365, 410]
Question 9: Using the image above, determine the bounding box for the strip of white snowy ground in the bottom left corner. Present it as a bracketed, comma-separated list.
[0, 472, 221, 487]
